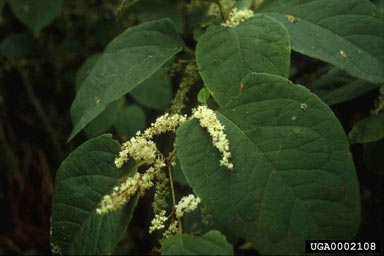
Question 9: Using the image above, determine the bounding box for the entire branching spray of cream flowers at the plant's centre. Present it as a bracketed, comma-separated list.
[96, 106, 233, 231]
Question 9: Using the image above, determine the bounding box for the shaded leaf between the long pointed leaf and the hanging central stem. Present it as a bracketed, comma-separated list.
[130, 68, 172, 110]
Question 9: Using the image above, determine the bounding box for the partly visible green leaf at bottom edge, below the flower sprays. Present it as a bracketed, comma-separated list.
[160, 230, 234, 255]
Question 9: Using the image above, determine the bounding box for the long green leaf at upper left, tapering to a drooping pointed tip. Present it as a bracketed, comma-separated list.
[68, 19, 183, 140]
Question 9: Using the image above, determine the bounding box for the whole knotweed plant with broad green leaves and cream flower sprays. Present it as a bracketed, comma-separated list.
[51, 0, 384, 255]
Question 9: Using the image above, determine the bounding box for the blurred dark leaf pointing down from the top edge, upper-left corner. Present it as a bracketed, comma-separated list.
[8, 0, 63, 33]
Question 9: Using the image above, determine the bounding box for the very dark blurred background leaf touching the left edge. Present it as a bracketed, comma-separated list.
[0, 33, 37, 58]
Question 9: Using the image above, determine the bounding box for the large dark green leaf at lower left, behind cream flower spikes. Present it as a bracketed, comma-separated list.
[50, 135, 137, 255]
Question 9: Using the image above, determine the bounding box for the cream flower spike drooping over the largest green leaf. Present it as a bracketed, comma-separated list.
[193, 106, 233, 170]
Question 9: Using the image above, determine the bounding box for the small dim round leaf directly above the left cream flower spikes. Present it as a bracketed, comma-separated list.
[115, 104, 145, 139]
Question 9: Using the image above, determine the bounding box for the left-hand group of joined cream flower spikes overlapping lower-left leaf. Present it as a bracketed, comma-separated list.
[96, 113, 187, 214]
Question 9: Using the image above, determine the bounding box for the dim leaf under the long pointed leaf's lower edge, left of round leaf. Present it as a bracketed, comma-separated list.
[84, 97, 124, 138]
